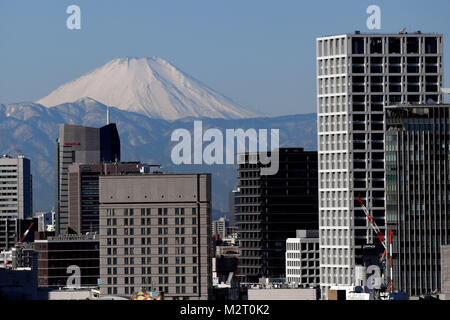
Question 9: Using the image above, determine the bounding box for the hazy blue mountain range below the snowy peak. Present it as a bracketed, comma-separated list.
[0, 98, 317, 215]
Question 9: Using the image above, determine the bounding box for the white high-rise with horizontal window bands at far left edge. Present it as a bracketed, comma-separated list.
[0, 155, 33, 219]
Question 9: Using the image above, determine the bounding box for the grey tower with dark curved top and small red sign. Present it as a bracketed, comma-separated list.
[55, 123, 120, 234]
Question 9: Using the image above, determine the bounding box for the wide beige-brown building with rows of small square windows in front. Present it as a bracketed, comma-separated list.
[100, 174, 212, 300]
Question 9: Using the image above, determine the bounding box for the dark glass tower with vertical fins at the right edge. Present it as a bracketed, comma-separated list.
[385, 105, 450, 296]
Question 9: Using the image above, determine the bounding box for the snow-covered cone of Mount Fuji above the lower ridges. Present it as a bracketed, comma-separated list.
[36, 57, 262, 120]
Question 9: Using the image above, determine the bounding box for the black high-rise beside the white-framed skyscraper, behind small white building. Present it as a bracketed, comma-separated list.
[236, 148, 318, 283]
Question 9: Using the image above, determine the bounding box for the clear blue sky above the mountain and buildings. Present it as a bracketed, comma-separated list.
[0, 0, 450, 115]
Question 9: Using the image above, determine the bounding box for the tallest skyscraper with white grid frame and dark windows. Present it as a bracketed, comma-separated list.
[317, 32, 444, 295]
